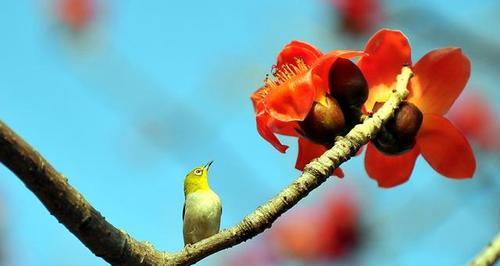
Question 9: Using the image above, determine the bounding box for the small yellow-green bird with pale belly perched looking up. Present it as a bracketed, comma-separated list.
[182, 161, 222, 245]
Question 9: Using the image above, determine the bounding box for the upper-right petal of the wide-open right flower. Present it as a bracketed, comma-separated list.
[408, 48, 470, 115]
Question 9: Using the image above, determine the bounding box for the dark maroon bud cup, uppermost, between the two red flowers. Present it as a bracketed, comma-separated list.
[328, 57, 368, 107]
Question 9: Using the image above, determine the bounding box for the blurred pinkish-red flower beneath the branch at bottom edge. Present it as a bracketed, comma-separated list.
[223, 188, 360, 266]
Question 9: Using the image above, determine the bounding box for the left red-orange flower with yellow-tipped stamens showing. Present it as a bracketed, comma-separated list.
[251, 41, 362, 177]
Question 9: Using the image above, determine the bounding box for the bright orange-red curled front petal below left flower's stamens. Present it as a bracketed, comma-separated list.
[264, 71, 316, 122]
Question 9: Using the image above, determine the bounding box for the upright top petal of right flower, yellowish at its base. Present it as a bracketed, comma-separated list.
[358, 29, 411, 111]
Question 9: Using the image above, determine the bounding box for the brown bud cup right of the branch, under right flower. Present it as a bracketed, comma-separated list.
[373, 102, 423, 154]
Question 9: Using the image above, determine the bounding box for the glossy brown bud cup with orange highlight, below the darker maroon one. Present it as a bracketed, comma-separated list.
[299, 95, 345, 145]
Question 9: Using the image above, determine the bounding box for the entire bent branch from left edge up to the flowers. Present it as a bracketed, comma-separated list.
[0, 67, 412, 265]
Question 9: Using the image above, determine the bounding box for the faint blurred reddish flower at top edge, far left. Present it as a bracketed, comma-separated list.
[56, 0, 96, 31]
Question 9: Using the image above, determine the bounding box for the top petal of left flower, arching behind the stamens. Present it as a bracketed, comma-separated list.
[276, 41, 322, 68]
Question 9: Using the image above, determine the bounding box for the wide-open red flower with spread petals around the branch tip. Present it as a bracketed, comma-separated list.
[358, 29, 476, 187]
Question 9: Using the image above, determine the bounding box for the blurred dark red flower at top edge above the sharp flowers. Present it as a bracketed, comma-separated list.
[331, 0, 383, 35]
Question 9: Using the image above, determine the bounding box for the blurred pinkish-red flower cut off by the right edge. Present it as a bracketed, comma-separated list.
[447, 92, 500, 151]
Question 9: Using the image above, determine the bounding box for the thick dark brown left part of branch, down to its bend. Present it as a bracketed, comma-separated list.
[0, 122, 168, 265]
